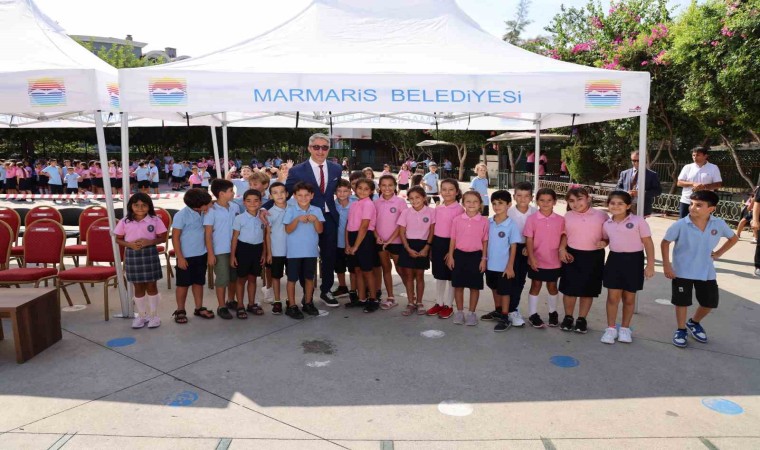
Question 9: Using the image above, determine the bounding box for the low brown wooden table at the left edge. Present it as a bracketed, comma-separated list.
[0, 288, 62, 364]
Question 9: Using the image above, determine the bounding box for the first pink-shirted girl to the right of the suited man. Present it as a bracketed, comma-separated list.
[346, 178, 380, 313]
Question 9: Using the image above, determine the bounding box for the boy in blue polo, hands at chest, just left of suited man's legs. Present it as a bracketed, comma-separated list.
[283, 182, 325, 320]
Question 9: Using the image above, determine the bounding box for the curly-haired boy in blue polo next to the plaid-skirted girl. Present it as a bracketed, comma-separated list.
[172, 189, 214, 323]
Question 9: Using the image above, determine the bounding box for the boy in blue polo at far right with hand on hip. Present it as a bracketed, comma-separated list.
[660, 191, 739, 347]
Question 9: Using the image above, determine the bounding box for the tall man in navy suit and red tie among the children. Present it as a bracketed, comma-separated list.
[276, 133, 343, 307]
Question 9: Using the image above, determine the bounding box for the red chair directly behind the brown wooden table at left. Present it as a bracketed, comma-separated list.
[0, 219, 72, 305]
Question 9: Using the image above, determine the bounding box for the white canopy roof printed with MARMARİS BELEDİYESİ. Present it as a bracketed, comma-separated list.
[119, 0, 649, 129]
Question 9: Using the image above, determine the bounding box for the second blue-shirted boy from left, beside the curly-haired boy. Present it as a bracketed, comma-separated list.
[203, 179, 240, 320]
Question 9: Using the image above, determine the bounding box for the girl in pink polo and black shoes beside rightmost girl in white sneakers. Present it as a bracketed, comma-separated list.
[559, 187, 609, 334]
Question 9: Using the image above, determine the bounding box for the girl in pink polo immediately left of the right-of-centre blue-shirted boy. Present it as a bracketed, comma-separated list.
[446, 191, 488, 326]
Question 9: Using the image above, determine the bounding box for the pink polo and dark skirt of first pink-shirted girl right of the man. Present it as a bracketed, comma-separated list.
[346, 197, 380, 272]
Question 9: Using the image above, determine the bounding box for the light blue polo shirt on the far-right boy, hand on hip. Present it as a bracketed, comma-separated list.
[663, 216, 734, 281]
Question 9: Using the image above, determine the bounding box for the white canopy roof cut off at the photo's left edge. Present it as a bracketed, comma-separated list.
[0, 0, 119, 117]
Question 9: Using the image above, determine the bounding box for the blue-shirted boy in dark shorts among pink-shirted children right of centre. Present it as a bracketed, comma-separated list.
[480, 190, 522, 331]
